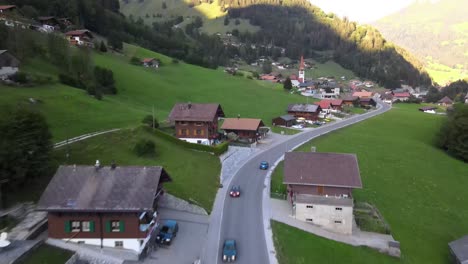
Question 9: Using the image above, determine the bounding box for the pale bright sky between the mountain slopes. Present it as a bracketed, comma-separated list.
[309, 0, 437, 23]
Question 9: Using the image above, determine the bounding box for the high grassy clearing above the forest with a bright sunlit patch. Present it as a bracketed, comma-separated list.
[120, 0, 259, 34]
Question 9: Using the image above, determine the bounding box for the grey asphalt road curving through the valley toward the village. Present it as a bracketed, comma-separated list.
[201, 101, 391, 264]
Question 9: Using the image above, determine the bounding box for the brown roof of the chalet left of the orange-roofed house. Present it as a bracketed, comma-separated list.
[169, 103, 224, 122]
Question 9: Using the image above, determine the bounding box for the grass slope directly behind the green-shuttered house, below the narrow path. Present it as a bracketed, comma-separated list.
[54, 127, 221, 212]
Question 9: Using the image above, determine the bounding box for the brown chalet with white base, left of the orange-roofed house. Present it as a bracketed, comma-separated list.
[169, 103, 224, 145]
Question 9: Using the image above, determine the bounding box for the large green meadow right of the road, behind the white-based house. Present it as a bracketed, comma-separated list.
[272, 104, 468, 263]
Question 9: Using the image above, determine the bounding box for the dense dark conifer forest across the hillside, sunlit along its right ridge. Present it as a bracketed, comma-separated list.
[9, 0, 431, 88]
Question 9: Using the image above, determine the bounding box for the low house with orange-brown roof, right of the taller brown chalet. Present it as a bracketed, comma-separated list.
[221, 118, 265, 143]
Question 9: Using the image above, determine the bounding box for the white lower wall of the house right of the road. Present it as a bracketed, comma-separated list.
[295, 202, 353, 234]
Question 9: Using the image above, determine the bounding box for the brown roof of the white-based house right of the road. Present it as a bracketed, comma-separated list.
[283, 152, 362, 188]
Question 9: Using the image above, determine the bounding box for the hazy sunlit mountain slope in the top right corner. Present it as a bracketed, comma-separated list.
[374, 0, 468, 83]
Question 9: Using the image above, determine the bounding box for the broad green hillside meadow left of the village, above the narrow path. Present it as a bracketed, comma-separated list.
[0, 46, 305, 141]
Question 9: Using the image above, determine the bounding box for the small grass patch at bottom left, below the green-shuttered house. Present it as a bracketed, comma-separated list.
[19, 244, 73, 264]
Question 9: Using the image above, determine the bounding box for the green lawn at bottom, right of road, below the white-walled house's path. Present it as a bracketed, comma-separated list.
[271, 221, 399, 264]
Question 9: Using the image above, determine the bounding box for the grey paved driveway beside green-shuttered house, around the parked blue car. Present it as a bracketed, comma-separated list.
[142, 209, 209, 264]
